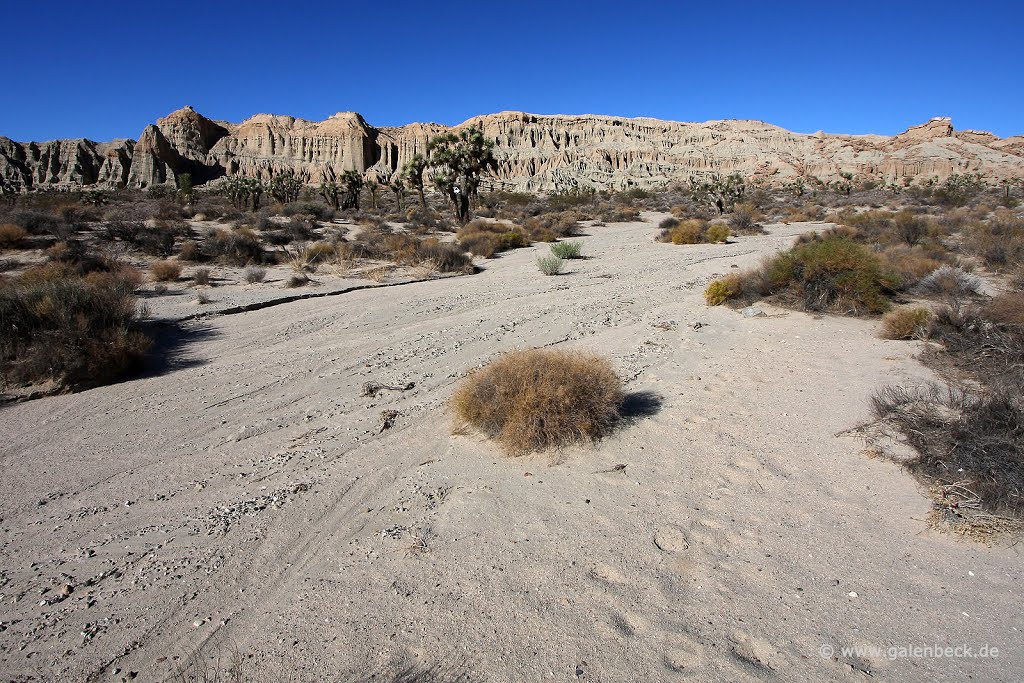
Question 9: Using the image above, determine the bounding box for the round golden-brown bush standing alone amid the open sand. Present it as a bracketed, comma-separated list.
[452, 349, 625, 455]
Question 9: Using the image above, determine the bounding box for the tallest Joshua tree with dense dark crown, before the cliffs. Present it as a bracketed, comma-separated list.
[427, 126, 498, 223]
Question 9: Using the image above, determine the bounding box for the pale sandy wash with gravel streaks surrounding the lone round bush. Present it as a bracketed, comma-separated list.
[0, 215, 1024, 682]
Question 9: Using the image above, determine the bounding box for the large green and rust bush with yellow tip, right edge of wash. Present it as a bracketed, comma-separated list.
[706, 230, 901, 315]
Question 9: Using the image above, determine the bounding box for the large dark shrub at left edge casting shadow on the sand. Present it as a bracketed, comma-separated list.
[0, 262, 150, 388]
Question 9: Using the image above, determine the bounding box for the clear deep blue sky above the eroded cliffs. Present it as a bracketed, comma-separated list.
[0, 0, 1024, 140]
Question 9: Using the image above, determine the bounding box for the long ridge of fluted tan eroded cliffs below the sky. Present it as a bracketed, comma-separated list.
[6, 106, 1024, 191]
